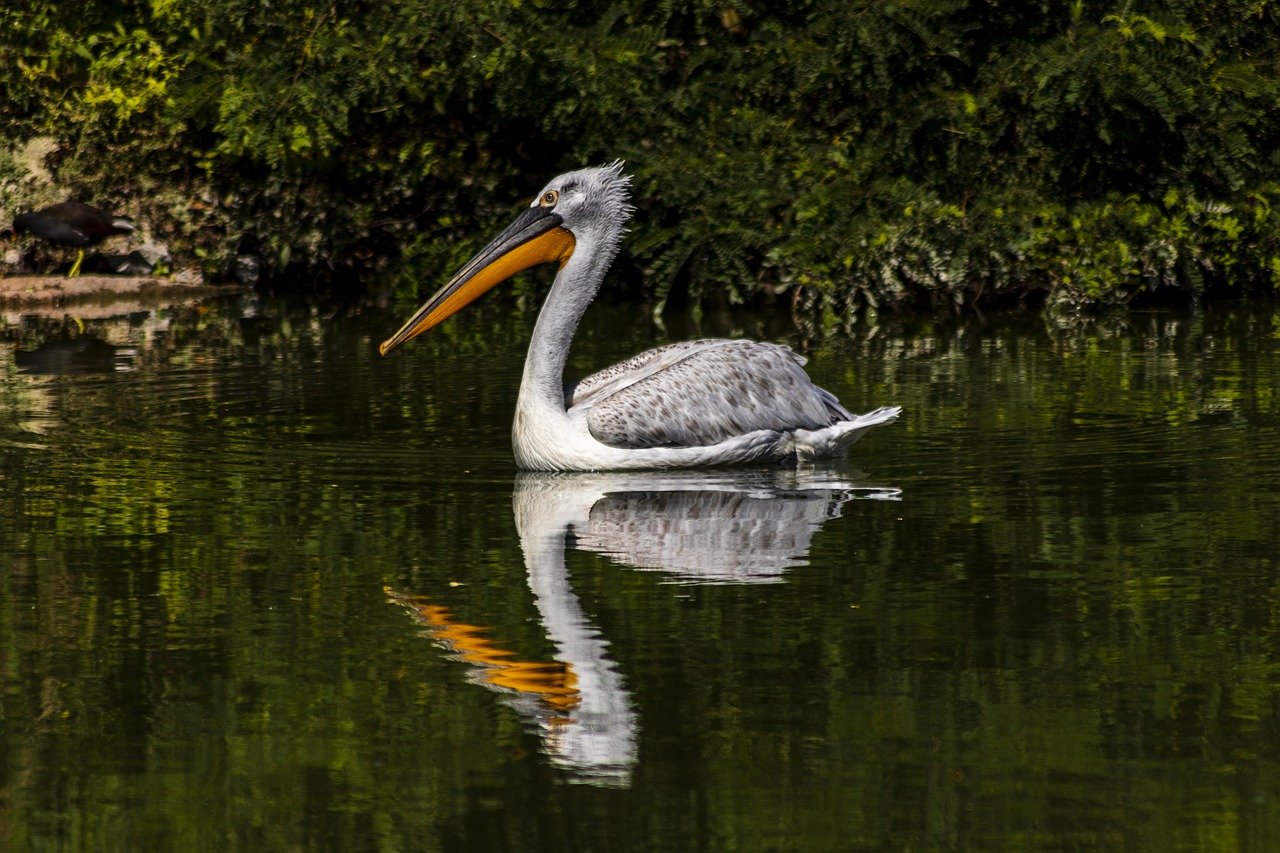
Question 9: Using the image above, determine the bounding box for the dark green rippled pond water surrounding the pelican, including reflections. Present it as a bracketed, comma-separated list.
[0, 290, 1280, 852]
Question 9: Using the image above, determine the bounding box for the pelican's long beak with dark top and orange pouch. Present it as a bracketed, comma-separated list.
[378, 206, 575, 355]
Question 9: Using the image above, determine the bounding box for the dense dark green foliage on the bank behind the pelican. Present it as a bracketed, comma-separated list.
[0, 0, 1280, 312]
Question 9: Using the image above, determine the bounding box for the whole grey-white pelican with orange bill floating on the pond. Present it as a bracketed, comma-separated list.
[380, 161, 902, 471]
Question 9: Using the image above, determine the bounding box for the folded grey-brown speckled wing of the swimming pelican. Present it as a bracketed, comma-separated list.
[566, 341, 852, 448]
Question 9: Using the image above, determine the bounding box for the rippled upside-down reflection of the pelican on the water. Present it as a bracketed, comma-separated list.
[388, 470, 899, 785]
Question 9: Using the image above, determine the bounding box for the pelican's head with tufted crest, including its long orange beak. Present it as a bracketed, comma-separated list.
[379, 160, 632, 355]
